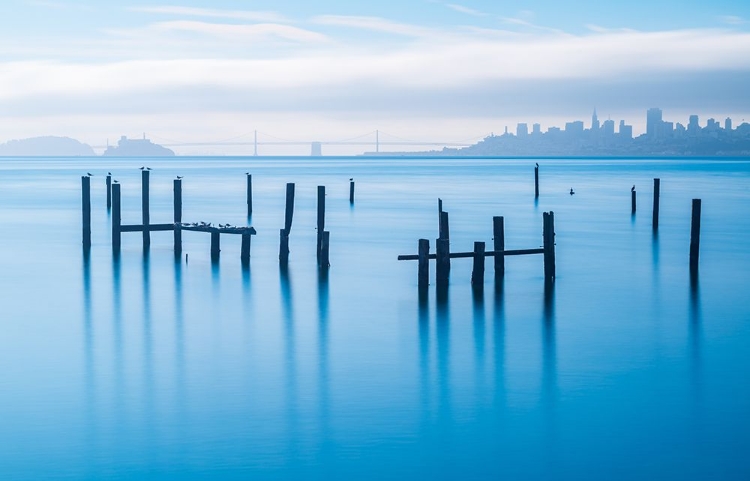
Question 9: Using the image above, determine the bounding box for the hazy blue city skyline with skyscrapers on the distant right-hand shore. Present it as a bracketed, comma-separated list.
[365, 108, 750, 157]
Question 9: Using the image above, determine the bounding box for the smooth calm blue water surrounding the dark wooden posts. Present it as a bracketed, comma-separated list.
[0, 158, 750, 480]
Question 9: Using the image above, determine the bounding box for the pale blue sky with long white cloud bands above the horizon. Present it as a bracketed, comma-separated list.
[0, 0, 750, 155]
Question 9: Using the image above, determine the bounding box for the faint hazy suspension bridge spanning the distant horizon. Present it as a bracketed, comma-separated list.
[94, 130, 486, 155]
